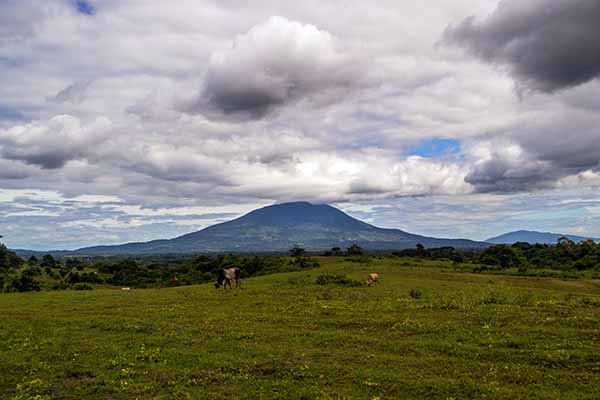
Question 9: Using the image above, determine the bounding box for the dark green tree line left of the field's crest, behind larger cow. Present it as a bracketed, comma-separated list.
[0, 239, 319, 292]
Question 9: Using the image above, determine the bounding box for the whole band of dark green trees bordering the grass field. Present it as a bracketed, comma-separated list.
[0, 238, 600, 292]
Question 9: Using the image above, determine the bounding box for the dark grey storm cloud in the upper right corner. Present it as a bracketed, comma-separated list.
[443, 0, 600, 92]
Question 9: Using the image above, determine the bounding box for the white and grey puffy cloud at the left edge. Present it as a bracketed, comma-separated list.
[0, 115, 111, 169]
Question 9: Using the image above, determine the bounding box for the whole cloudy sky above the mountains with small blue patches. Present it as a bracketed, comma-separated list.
[0, 0, 600, 250]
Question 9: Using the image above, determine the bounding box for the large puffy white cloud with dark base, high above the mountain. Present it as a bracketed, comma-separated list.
[195, 17, 359, 117]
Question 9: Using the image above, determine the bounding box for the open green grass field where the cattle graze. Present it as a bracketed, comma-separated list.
[0, 258, 600, 400]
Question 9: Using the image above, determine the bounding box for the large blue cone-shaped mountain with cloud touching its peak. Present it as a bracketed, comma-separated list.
[28, 202, 488, 255]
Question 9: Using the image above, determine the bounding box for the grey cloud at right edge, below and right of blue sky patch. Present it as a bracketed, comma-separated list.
[465, 110, 600, 192]
